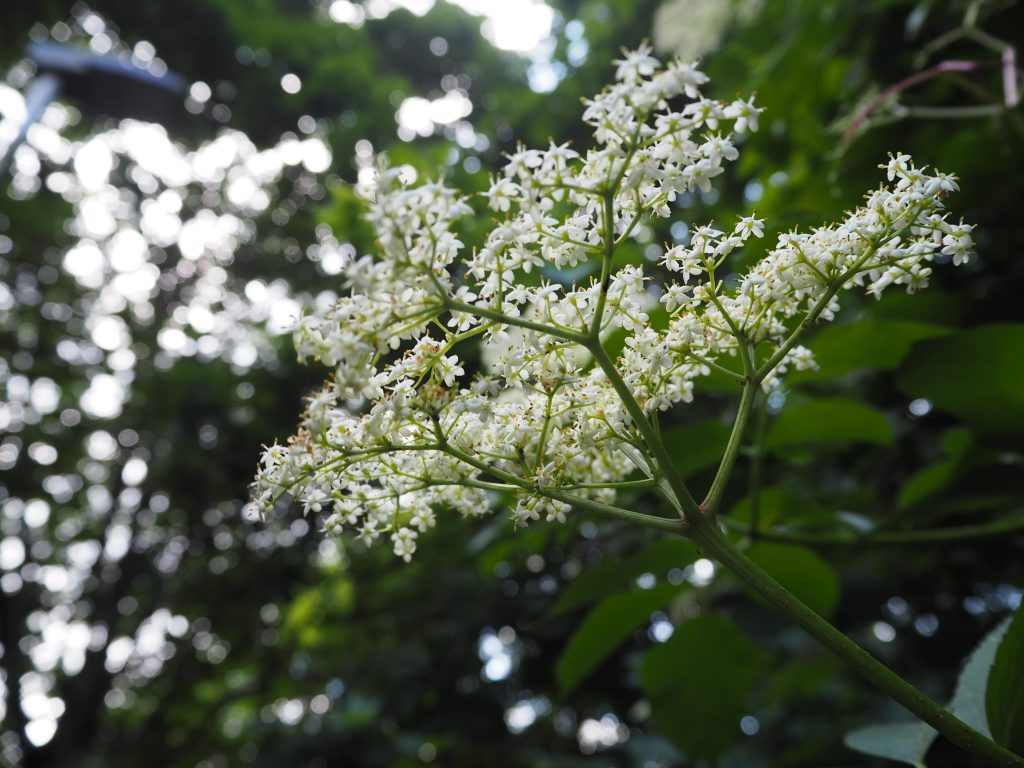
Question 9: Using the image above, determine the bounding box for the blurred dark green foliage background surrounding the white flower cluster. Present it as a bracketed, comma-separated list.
[0, 0, 1024, 768]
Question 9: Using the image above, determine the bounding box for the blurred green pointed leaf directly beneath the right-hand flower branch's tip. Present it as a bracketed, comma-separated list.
[787, 317, 949, 383]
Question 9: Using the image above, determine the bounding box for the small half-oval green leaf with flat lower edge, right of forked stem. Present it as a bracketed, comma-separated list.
[765, 397, 893, 450]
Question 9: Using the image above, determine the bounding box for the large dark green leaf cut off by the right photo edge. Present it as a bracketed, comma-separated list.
[899, 324, 1024, 433]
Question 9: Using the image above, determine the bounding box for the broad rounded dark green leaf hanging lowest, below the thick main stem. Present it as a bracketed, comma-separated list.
[640, 614, 767, 759]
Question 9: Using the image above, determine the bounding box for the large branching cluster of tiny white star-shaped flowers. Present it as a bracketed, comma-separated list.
[254, 48, 972, 561]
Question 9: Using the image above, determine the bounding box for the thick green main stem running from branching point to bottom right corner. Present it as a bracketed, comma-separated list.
[688, 518, 1024, 766]
